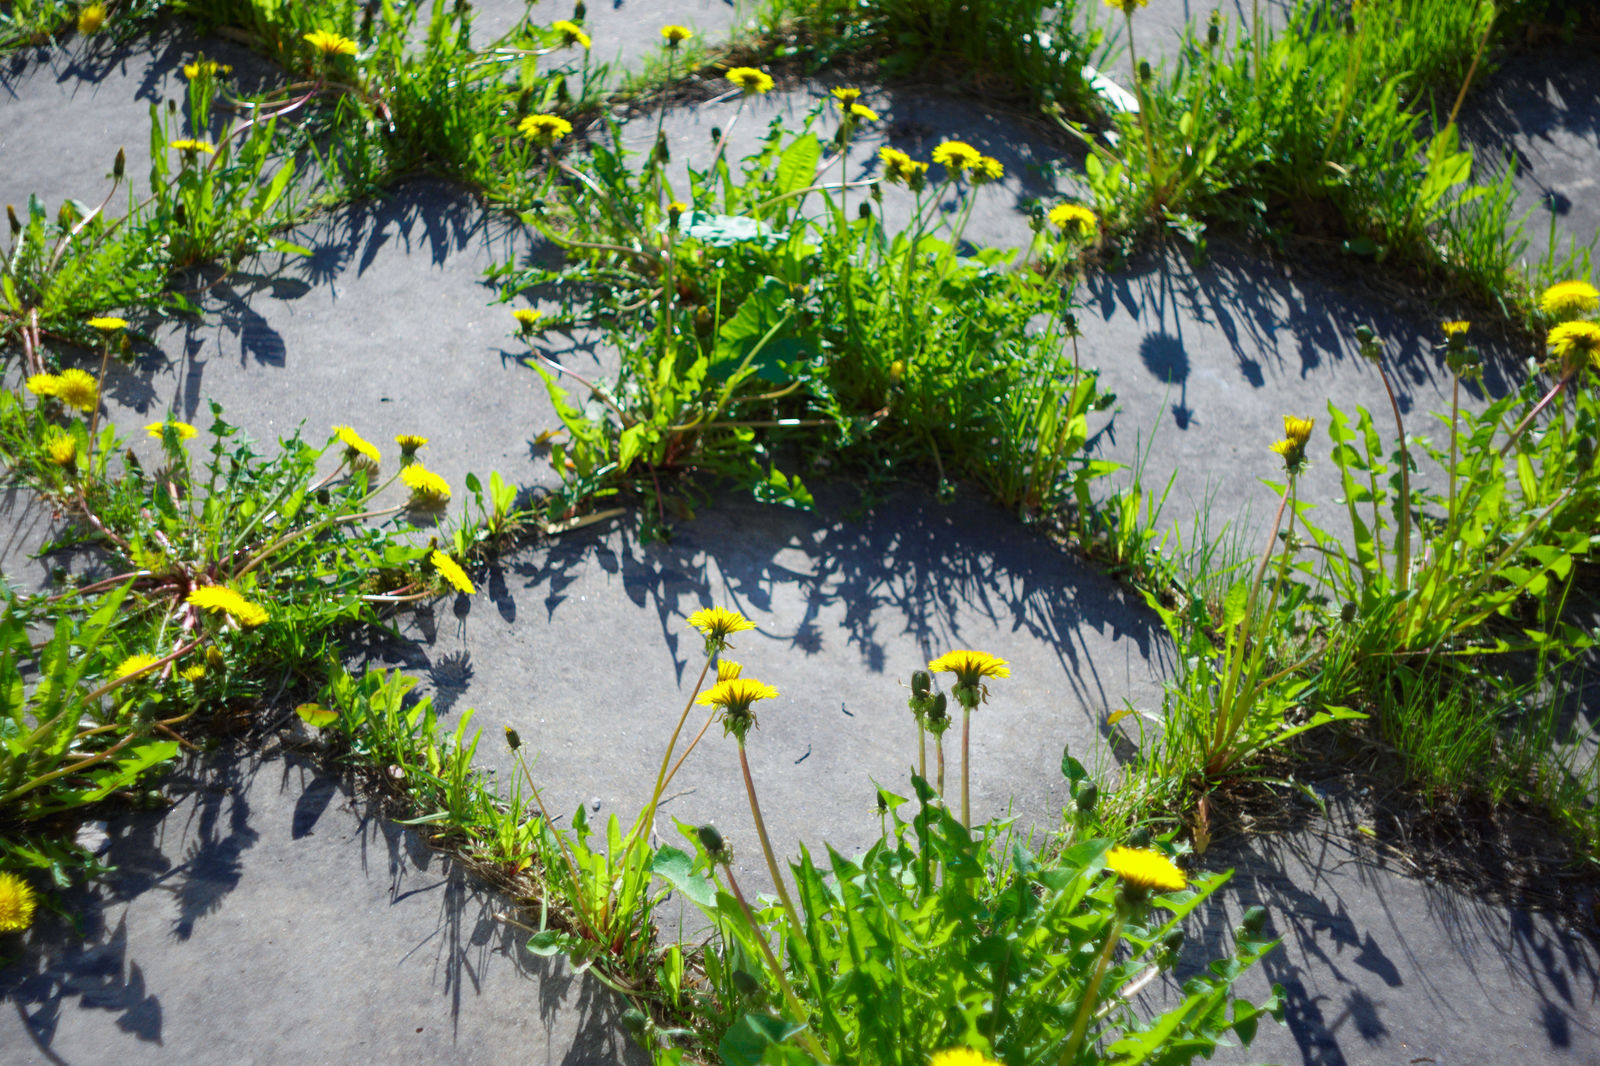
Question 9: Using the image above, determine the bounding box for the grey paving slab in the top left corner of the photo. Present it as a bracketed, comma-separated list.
[0, 24, 282, 216]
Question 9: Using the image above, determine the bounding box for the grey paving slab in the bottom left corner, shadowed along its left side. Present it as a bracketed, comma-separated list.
[0, 745, 645, 1066]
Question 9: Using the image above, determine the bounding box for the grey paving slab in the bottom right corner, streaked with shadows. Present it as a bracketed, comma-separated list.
[1190, 810, 1600, 1066]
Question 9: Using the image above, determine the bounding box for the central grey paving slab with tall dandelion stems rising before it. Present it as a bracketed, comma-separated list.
[363, 485, 1168, 884]
